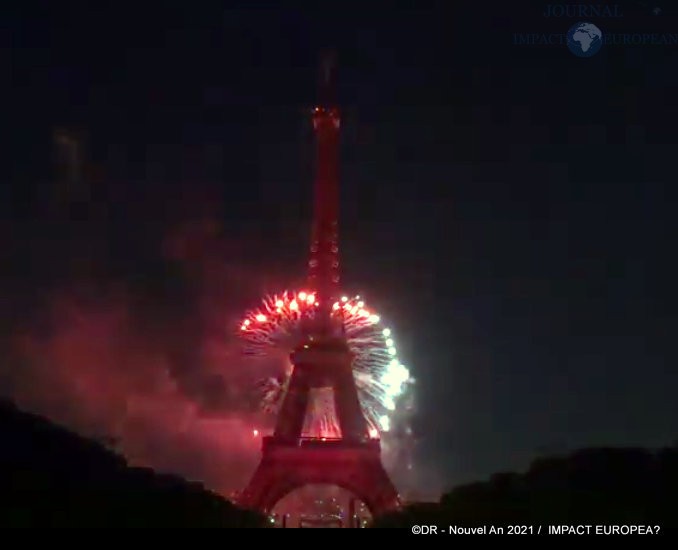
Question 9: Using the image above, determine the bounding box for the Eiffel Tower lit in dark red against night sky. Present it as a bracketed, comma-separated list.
[239, 55, 400, 516]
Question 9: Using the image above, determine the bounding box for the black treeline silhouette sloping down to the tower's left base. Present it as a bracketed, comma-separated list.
[0, 403, 265, 527]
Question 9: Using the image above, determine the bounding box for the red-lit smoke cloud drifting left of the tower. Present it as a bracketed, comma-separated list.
[1, 215, 282, 494]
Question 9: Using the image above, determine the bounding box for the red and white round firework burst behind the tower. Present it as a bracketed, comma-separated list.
[239, 291, 411, 438]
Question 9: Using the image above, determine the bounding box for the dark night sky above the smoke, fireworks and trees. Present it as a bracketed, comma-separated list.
[0, 1, 678, 498]
